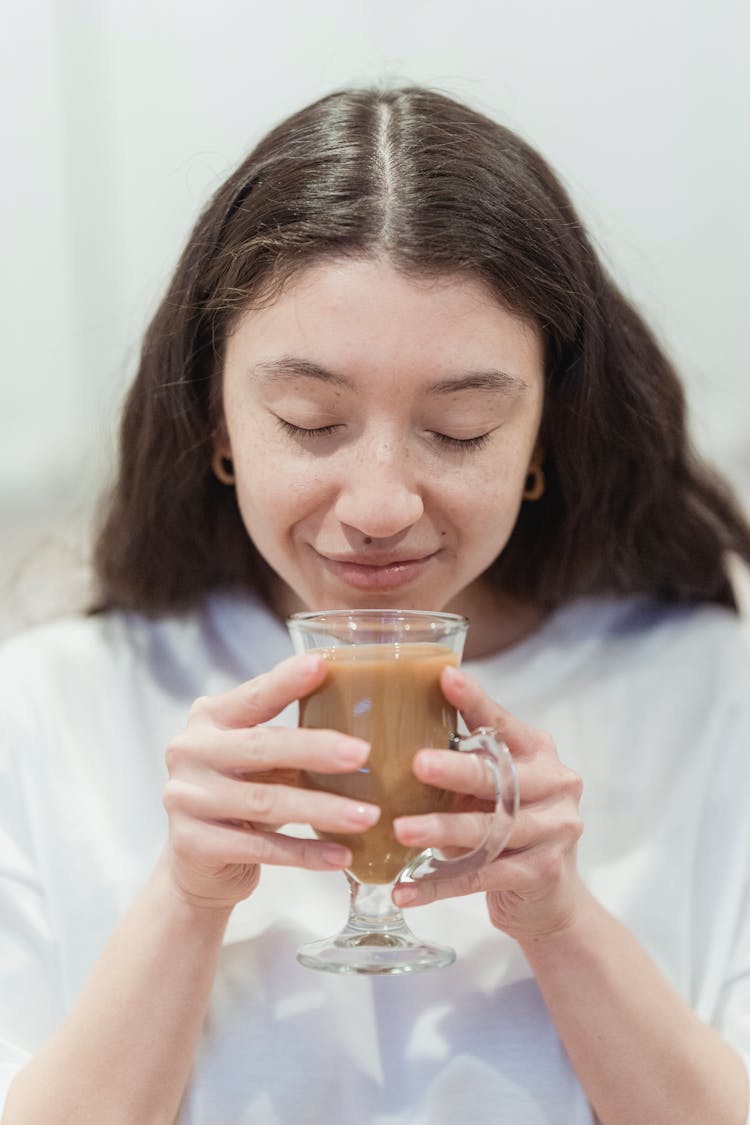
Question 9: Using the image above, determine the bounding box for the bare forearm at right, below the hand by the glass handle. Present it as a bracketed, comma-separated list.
[523, 889, 748, 1125]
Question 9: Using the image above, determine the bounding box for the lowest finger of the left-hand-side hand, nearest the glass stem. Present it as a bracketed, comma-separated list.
[171, 820, 352, 871]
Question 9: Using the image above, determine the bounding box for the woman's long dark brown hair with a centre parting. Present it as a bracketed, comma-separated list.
[96, 89, 750, 614]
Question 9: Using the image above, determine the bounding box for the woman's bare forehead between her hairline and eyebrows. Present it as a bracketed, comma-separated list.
[226, 258, 542, 377]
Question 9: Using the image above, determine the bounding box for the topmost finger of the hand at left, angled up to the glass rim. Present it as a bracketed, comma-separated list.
[191, 653, 326, 727]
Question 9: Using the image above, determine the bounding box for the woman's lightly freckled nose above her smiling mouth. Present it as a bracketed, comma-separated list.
[335, 442, 424, 539]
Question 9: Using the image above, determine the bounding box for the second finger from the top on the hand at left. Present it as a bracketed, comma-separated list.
[166, 726, 370, 776]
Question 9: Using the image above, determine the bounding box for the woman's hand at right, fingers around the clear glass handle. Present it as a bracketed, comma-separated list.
[394, 668, 584, 944]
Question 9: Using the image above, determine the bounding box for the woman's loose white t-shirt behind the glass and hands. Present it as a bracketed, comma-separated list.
[0, 596, 750, 1125]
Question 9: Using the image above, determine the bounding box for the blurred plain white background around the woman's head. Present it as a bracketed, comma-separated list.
[0, 0, 750, 632]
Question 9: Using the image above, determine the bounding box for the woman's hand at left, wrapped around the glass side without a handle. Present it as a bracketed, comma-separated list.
[163, 654, 379, 909]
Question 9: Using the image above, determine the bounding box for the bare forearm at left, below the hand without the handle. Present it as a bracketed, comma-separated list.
[2, 861, 229, 1125]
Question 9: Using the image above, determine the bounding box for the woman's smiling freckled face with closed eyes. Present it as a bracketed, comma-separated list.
[217, 259, 543, 610]
